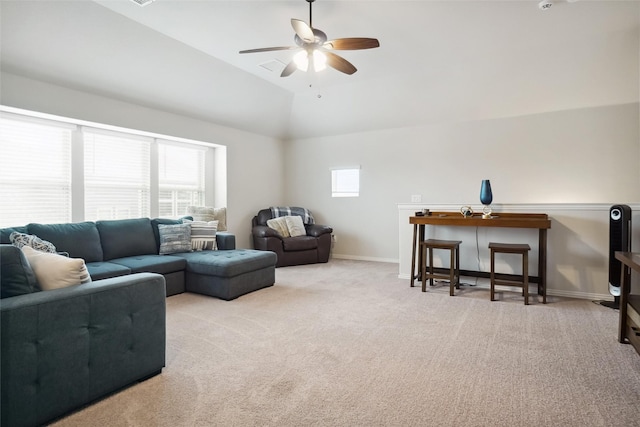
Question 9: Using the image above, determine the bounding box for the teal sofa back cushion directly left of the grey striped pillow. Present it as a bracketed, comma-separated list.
[96, 218, 157, 261]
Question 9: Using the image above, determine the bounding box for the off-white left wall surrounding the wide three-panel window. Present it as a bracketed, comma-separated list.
[0, 73, 284, 248]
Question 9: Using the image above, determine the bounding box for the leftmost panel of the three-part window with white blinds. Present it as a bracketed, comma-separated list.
[0, 114, 75, 227]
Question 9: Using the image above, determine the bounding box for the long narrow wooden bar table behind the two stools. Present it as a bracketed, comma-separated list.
[409, 212, 551, 304]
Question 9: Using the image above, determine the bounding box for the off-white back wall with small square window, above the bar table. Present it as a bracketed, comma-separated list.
[285, 103, 640, 261]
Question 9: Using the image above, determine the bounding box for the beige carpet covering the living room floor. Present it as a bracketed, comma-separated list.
[56, 260, 640, 427]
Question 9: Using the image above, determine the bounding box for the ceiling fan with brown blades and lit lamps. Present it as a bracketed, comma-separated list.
[240, 0, 380, 77]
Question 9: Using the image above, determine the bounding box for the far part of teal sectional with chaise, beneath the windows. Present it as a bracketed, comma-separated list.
[0, 218, 277, 300]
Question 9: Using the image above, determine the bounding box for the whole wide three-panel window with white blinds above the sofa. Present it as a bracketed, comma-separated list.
[0, 106, 226, 227]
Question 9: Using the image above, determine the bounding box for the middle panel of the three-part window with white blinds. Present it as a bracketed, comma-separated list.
[83, 128, 152, 221]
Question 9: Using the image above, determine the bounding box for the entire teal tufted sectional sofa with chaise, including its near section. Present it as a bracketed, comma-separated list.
[0, 218, 277, 426]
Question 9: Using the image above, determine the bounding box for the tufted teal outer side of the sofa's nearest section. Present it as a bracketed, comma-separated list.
[0, 273, 166, 425]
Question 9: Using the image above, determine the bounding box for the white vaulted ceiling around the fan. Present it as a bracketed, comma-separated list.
[0, 0, 640, 138]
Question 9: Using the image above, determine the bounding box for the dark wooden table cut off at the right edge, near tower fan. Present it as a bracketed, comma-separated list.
[615, 252, 640, 354]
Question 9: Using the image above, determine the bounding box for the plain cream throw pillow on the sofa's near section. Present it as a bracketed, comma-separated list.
[22, 246, 91, 291]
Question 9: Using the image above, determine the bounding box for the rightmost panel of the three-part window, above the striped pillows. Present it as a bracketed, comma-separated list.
[158, 142, 206, 218]
